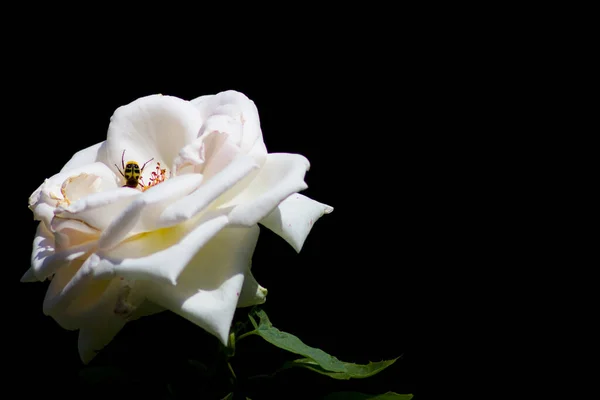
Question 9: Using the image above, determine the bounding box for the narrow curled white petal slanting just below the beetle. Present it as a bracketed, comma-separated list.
[98, 174, 203, 249]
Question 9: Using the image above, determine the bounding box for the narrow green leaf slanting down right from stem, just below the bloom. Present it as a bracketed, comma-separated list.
[248, 310, 348, 373]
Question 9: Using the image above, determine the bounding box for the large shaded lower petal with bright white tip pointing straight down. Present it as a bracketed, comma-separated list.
[147, 226, 260, 344]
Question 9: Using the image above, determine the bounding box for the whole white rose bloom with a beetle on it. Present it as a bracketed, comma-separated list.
[22, 91, 333, 363]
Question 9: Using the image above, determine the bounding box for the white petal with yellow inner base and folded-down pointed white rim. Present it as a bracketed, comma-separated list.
[95, 209, 229, 285]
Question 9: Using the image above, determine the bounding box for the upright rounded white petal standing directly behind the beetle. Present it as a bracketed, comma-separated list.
[106, 95, 203, 177]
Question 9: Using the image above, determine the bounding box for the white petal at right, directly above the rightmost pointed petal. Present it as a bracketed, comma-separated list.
[224, 153, 310, 226]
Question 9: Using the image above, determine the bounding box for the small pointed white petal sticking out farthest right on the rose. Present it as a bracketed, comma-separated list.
[260, 193, 333, 252]
